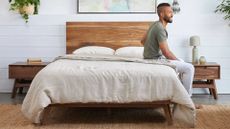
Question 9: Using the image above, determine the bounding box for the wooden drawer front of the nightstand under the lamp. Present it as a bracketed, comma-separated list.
[194, 66, 220, 79]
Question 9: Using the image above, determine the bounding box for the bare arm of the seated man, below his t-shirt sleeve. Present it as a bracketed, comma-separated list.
[159, 41, 178, 60]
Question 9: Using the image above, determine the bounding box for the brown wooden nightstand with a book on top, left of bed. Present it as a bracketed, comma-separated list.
[9, 62, 48, 98]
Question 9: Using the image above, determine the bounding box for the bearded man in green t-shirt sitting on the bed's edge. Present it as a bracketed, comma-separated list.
[141, 3, 199, 108]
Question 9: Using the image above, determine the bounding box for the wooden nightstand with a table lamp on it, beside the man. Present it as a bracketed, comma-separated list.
[193, 62, 220, 99]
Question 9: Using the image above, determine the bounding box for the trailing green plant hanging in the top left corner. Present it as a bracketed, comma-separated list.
[10, 0, 40, 23]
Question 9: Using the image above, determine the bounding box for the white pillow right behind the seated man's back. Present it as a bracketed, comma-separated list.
[115, 47, 144, 58]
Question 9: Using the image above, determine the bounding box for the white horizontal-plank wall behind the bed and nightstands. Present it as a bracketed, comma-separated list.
[0, 0, 230, 93]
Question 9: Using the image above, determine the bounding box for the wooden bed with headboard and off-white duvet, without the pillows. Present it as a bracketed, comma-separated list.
[22, 22, 195, 127]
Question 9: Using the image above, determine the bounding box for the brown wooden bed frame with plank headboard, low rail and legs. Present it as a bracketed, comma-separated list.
[44, 22, 173, 125]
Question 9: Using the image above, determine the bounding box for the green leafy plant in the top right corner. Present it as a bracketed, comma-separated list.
[215, 0, 230, 20]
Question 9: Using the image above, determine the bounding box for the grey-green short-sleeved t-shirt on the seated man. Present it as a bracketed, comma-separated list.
[143, 21, 168, 59]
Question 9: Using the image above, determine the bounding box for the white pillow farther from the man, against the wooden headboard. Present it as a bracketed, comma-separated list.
[73, 46, 115, 55]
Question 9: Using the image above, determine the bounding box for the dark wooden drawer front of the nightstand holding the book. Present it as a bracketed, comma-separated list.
[9, 66, 44, 79]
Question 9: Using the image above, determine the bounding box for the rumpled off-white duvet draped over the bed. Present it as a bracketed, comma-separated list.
[22, 55, 195, 127]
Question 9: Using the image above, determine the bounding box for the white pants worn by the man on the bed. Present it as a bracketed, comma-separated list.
[170, 60, 194, 96]
